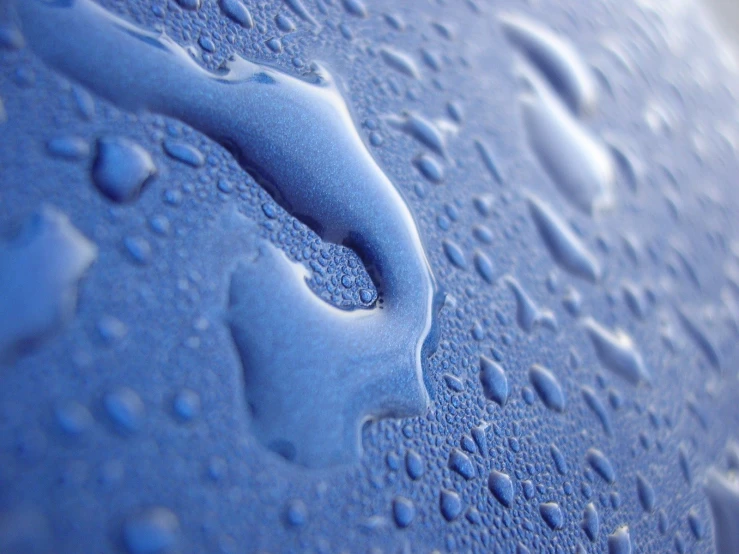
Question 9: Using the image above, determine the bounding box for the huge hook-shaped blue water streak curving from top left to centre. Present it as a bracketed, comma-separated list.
[15, 0, 436, 466]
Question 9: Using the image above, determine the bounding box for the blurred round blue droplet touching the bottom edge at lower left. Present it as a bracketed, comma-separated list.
[123, 506, 180, 554]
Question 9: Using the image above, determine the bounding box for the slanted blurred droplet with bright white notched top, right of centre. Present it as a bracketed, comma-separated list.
[584, 318, 651, 385]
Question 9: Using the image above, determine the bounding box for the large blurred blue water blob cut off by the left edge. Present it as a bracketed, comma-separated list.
[0, 206, 97, 358]
